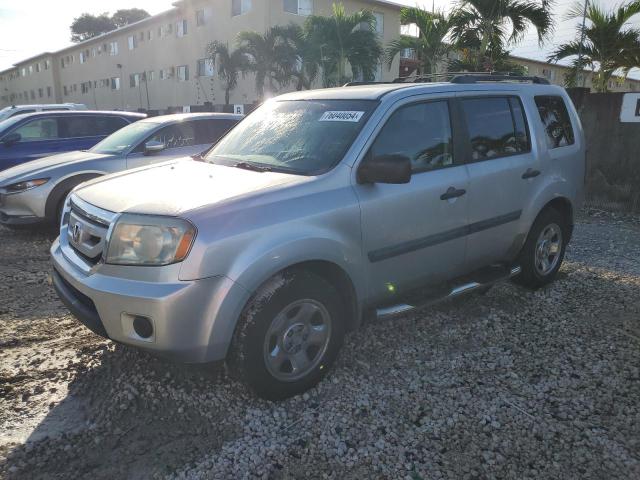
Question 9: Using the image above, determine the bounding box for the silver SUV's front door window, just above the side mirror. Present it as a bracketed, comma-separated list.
[371, 101, 453, 172]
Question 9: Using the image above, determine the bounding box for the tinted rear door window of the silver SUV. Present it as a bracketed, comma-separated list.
[462, 97, 529, 161]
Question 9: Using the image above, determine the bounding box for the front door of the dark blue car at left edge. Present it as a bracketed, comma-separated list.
[0, 116, 66, 170]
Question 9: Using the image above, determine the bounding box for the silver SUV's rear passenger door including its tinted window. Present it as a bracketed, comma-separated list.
[458, 92, 542, 270]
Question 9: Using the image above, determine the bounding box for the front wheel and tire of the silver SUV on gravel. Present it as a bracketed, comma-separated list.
[231, 270, 346, 400]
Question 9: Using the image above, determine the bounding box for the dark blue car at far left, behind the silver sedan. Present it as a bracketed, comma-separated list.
[0, 110, 146, 171]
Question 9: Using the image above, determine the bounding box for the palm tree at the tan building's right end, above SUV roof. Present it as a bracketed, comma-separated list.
[384, 7, 452, 79]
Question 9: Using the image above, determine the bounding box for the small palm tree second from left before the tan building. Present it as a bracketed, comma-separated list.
[238, 26, 296, 100]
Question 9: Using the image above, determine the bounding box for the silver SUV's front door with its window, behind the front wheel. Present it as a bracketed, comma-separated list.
[355, 99, 468, 301]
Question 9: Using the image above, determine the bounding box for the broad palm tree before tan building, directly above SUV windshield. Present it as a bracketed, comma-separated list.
[305, 3, 382, 86]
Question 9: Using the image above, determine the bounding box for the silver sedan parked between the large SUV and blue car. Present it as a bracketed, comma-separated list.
[0, 113, 242, 226]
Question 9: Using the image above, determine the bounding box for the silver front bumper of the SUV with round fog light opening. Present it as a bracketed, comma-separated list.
[51, 240, 249, 363]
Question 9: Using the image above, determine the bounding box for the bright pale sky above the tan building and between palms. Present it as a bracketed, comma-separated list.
[0, 0, 640, 78]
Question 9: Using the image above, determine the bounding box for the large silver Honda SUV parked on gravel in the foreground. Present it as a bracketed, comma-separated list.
[51, 76, 585, 399]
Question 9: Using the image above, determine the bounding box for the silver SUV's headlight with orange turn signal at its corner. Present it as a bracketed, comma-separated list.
[105, 214, 196, 266]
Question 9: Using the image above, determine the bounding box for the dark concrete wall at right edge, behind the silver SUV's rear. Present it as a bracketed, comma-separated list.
[569, 89, 640, 211]
